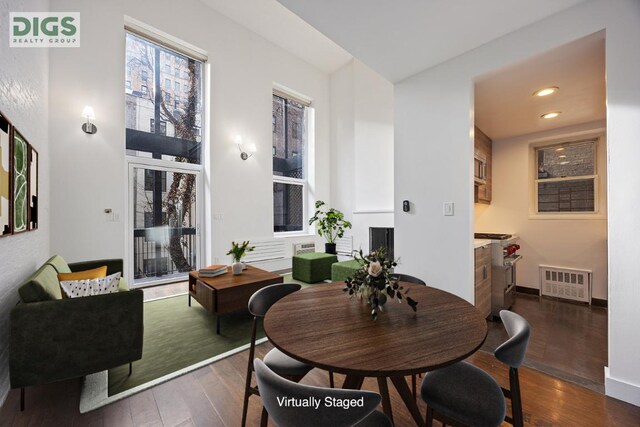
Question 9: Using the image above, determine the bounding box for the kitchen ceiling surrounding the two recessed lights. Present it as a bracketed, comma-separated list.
[475, 32, 606, 140]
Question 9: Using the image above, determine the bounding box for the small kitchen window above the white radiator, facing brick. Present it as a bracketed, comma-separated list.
[535, 140, 598, 213]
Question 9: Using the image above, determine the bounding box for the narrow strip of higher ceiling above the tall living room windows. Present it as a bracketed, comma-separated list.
[201, 0, 352, 73]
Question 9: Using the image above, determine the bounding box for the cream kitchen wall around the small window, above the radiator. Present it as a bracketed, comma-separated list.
[475, 122, 607, 299]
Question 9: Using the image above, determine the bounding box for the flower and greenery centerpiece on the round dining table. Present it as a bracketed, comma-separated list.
[344, 248, 418, 320]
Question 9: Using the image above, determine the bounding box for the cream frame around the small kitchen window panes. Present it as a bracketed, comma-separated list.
[529, 137, 606, 220]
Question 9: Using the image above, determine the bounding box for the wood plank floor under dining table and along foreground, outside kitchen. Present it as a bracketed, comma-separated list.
[0, 343, 640, 427]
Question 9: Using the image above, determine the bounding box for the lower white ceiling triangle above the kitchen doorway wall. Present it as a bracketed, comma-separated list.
[274, 0, 584, 83]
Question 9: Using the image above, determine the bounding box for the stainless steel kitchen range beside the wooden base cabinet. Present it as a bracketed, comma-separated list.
[475, 233, 522, 316]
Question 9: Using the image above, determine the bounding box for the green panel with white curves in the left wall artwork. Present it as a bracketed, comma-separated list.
[13, 131, 29, 232]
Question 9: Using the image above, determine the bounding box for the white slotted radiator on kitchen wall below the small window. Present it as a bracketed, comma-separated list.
[540, 265, 593, 304]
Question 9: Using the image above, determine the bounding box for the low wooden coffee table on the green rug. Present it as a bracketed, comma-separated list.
[189, 266, 283, 335]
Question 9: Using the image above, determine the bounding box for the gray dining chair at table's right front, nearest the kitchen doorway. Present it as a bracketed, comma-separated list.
[421, 310, 531, 427]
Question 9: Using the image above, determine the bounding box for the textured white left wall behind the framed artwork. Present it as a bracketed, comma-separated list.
[0, 0, 50, 406]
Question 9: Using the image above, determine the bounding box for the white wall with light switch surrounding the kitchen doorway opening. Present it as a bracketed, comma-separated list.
[395, 0, 640, 405]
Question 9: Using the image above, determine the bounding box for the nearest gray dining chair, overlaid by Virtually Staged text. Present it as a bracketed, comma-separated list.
[253, 359, 392, 427]
